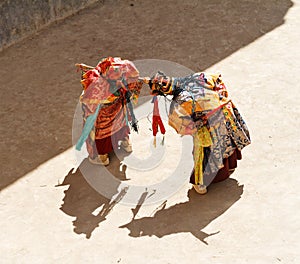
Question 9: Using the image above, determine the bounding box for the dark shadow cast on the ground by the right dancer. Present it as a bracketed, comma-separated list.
[120, 178, 243, 244]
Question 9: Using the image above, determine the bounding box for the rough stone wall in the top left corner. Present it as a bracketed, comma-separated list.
[0, 0, 98, 51]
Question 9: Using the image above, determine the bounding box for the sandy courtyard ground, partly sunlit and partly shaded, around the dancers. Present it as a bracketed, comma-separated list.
[0, 1, 300, 263]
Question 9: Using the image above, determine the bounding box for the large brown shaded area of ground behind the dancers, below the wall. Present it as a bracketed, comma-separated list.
[0, 0, 292, 190]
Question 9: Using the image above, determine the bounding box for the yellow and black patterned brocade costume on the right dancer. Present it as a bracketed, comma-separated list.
[149, 72, 250, 186]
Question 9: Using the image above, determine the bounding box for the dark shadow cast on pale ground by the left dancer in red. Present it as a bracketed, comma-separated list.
[57, 150, 127, 239]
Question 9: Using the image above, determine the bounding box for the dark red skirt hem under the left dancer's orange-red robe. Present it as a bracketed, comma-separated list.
[95, 126, 130, 155]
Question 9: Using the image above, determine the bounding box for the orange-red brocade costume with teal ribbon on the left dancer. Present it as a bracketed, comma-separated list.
[76, 57, 142, 158]
